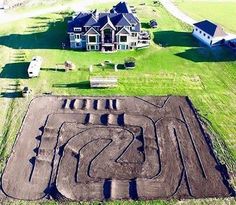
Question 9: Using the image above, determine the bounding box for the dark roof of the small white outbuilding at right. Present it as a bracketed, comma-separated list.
[193, 20, 227, 37]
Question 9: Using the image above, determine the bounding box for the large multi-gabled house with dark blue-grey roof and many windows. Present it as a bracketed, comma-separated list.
[68, 2, 150, 51]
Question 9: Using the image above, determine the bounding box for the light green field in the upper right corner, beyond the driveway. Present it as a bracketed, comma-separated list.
[173, 0, 236, 33]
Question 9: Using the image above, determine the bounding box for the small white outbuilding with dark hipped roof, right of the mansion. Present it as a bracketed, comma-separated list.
[192, 20, 227, 46]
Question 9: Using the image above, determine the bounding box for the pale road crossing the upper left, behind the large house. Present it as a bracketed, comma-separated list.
[0, 0, 112, 24]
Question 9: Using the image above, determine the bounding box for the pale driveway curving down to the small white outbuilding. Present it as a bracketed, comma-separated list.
[160, 0, 197, 26]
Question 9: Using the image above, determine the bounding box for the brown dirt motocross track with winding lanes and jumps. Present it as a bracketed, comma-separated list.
[2, 96, 233, 201]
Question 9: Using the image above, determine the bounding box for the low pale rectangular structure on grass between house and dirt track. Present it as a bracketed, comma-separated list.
[90, 77, 118, 88]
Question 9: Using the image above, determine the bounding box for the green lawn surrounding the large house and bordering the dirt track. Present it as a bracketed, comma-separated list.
[0, 1, 236, 204]
